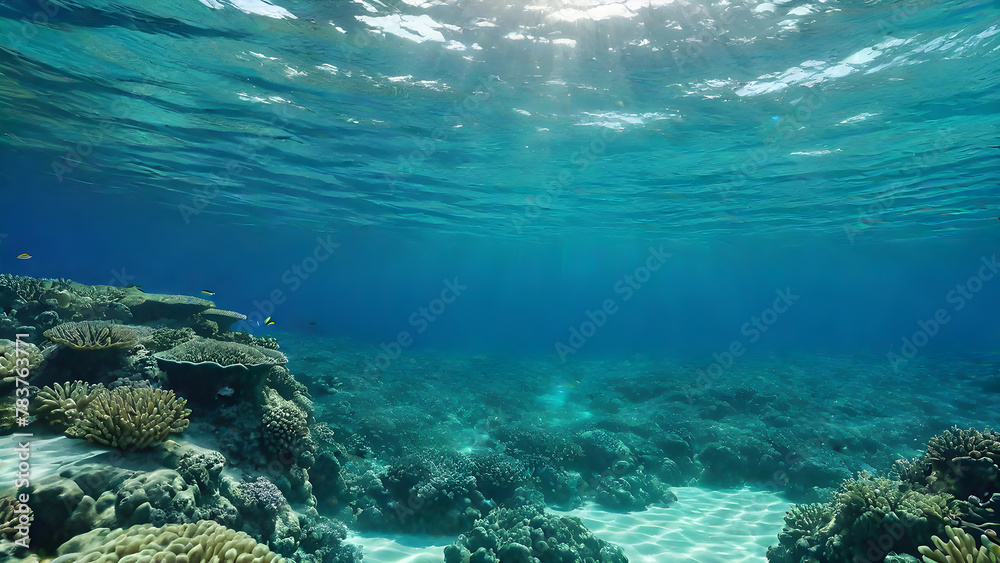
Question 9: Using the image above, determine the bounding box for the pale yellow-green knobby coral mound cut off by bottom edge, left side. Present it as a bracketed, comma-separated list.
[52, 520, 285, 563]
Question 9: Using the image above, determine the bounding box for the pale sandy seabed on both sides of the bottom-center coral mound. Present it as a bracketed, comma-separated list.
[348, 487, 791, 563]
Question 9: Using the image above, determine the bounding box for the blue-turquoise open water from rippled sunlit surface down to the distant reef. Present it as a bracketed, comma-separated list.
[0, 0, 1000, 361]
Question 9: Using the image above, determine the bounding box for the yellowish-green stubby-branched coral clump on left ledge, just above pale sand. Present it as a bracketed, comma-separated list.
[34, 381, 191, 450]
